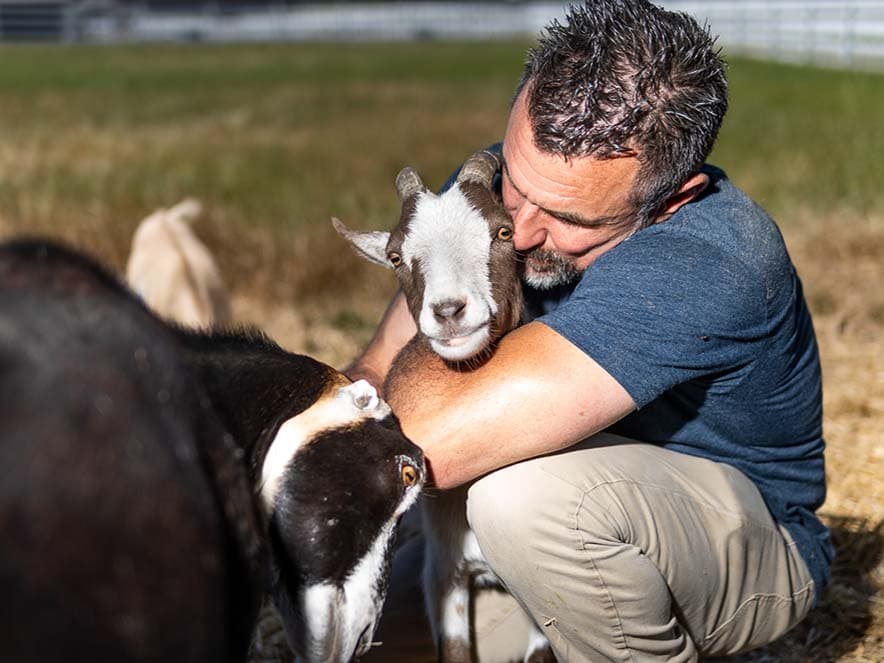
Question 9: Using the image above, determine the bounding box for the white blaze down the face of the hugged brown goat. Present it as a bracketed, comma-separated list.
[402, 185, 497, 360]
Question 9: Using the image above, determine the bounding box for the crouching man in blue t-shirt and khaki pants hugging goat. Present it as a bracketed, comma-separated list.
[352, 0, 832, 661]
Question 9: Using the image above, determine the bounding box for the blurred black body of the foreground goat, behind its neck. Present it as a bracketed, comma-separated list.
[0, 242, 252, 663]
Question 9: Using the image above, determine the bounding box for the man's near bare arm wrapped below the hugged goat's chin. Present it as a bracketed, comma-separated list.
[386, 320, 635, 488]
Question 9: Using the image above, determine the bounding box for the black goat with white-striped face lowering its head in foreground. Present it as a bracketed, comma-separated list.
[0, 242, 425, 663]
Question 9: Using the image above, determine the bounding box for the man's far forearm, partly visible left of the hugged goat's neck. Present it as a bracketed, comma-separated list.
[344, 291, 417, 392]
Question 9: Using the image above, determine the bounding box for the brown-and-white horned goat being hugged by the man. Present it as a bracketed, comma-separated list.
[335, 151, 555, 663]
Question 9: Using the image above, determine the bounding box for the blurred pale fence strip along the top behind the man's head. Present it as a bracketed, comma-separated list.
[0, 0, 884, 67]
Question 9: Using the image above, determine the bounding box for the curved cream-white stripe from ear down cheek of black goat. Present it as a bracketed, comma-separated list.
[261, 380, 391, 513]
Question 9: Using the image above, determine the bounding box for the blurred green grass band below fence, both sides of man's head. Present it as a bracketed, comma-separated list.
[0, 43, 884, 236]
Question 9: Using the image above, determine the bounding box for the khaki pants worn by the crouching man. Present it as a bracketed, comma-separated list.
[364, 434, 814, 663]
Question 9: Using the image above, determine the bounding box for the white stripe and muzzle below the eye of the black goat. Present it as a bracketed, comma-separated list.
[302, 472, 421, 663]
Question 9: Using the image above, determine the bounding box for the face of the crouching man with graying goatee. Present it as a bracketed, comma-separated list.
[503, 92, 639, 289]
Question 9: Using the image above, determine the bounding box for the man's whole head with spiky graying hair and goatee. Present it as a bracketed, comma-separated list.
[503, 0, 727, 287]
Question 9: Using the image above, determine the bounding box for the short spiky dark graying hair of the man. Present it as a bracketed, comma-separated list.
[516, 0, 727, 227]
